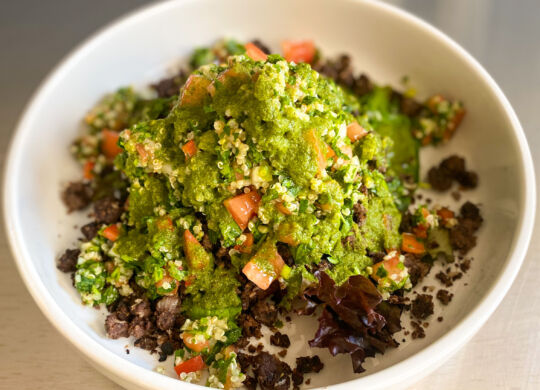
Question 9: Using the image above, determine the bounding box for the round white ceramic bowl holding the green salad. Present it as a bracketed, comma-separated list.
[4, 0, 535, 389]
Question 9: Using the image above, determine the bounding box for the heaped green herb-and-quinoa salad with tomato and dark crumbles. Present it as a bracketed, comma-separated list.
[58, 40, 482, 389]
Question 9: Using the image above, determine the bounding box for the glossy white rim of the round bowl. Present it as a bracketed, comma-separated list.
[3, 0, 536, 389]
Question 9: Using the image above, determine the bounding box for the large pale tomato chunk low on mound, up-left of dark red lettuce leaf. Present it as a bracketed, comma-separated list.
[242, 242, 285, 290]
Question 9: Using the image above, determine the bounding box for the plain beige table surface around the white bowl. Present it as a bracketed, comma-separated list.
[0, 0, 540, 390]
